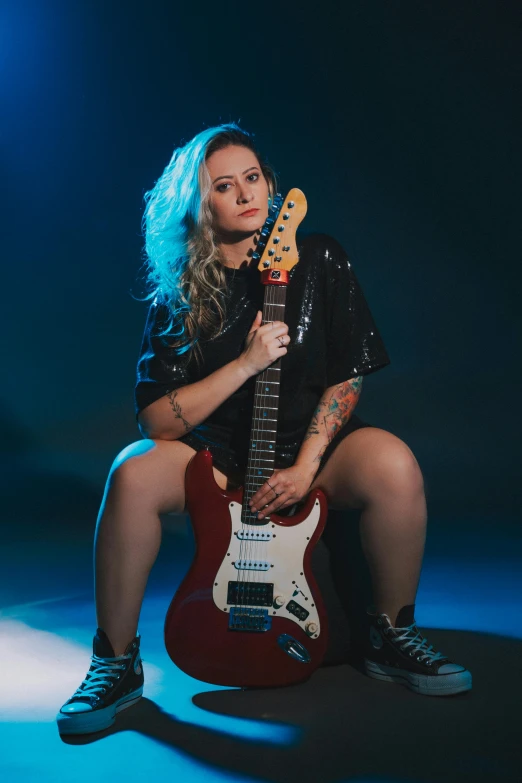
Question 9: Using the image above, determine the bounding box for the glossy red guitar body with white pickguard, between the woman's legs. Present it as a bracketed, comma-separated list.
[165, 449, 328, 687]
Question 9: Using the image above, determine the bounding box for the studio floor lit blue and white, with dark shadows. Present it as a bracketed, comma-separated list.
[0, 512, 522, 783]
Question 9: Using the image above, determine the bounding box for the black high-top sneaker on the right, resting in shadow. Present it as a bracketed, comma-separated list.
[364, 604, 471, 696]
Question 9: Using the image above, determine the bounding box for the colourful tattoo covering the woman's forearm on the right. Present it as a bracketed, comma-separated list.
[303, 375, 363, 462]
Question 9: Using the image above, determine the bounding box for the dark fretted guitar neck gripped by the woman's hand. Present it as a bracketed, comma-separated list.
[243, 285, 287, 524]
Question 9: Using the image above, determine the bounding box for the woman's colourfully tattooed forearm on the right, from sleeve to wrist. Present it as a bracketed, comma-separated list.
[294, 375, 363, 473]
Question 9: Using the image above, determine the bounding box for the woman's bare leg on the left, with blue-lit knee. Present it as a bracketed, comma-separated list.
[94, 439, 227, 655]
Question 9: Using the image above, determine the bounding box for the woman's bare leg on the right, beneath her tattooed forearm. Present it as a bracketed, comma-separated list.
[311, 427, 427, 623]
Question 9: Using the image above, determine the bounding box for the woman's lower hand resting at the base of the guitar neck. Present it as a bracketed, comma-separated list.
[249, 465, 317, 519]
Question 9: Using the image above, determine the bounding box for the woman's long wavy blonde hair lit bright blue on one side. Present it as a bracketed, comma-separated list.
[138, 122, 277, 363]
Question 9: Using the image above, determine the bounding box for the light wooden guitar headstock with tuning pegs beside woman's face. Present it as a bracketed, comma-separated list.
[253, 188, 307, 277]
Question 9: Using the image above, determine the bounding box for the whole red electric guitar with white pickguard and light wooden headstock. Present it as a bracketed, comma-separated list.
[164, 188, 328, 688]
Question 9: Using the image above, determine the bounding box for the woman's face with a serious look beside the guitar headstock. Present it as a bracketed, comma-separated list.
[206, 146, 268, 239]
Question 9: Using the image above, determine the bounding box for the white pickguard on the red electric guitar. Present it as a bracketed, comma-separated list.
[213, 500, 321, 638]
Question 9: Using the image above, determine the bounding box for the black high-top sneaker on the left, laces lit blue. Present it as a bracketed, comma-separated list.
[56, 628, 143, 734]
